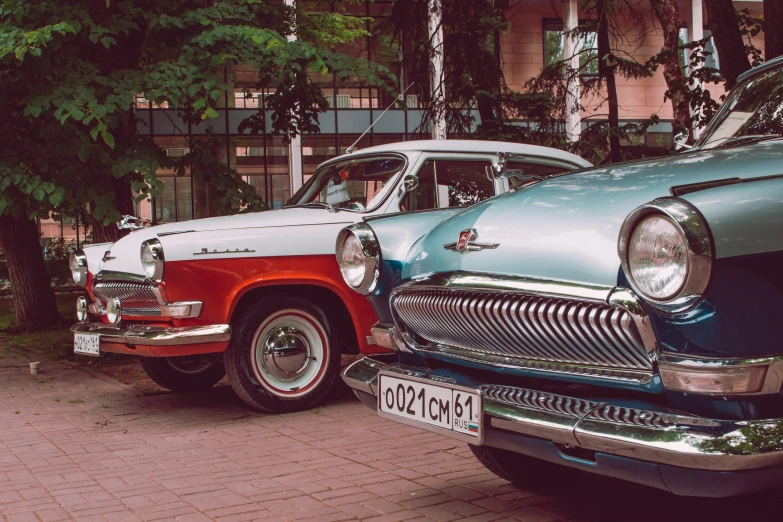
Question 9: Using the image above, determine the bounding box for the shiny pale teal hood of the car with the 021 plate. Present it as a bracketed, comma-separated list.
[402, 140, 783, 286]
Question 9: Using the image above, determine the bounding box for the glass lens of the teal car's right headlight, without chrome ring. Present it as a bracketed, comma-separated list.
[628, 216, 688, 301]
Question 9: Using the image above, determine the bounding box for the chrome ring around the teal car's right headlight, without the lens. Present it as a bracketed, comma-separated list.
[617, 198, 715, 313]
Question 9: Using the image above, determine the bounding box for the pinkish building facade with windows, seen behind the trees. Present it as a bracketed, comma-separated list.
[41, 0, 763, 244]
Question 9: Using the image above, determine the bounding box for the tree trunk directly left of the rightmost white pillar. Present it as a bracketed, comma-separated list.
[651, 0, 693, 138]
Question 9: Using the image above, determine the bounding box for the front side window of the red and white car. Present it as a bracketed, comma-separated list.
[400, 160, 495, 211]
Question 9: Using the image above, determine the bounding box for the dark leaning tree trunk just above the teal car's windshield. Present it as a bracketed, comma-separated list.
[704, 0, 750, 89]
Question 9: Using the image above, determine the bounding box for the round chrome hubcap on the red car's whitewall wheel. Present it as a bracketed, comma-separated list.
[262, 326, 313, 381]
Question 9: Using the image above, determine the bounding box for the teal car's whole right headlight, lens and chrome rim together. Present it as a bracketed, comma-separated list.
[617, 198, 713, 313]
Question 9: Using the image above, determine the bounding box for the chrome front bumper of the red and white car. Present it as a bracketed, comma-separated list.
[71, 323, 231, 346]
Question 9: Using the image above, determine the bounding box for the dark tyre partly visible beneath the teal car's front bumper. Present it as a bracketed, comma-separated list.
[470, 444, 574, 488]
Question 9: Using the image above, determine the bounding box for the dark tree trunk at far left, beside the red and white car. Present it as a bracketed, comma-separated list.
[0, 216, 62, 329]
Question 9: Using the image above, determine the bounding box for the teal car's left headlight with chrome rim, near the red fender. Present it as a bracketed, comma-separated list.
[336, 223, 380, 295]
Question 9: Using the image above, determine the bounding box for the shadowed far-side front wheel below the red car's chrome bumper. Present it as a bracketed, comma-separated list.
[141, 356, 226, 392]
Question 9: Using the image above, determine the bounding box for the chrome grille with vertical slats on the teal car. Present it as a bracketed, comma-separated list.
[391, 287, 652, 380]
